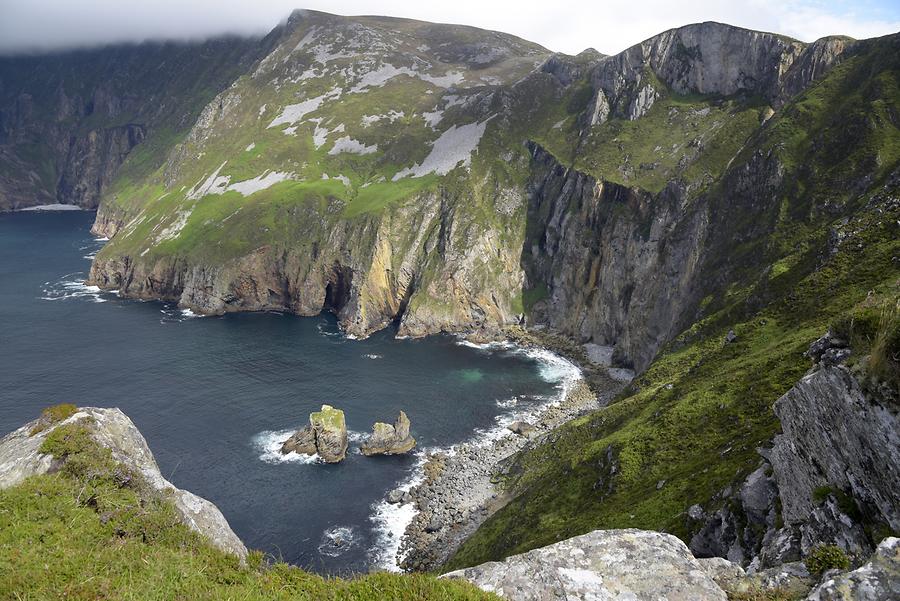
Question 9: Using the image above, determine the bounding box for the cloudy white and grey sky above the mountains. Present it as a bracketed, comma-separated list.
[0, 0, 900, 54]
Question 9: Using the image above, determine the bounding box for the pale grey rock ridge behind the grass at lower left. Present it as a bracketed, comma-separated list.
[0, 407, 247, 558]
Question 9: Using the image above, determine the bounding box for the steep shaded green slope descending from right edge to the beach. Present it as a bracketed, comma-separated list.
[449, 36, 900, 568]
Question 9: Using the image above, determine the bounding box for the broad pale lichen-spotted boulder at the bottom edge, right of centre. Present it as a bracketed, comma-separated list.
[443, 529, 726, 601]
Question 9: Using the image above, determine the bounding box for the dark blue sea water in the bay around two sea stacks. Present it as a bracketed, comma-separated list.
[0, 211, 573, 573]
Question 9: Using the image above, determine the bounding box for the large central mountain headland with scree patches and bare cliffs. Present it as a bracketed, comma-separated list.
[79, 11, 872, 370]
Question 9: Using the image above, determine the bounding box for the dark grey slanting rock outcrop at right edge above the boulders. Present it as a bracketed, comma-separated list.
[771, 365, 900, 540]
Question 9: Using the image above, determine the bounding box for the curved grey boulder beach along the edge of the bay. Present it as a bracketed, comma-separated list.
[389, 331, 623, 571]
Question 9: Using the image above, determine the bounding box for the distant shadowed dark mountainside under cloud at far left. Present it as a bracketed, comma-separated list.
[0, 38, 269, 210]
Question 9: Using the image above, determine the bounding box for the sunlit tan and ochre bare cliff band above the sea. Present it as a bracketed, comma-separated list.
[90, 185, 523, 337]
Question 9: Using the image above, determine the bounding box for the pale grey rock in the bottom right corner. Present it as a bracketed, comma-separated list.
[807, 537, 900, 601]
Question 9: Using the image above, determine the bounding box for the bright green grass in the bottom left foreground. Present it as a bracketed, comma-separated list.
[0, 423, 496, 601]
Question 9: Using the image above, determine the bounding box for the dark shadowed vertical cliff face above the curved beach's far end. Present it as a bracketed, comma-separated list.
[522, 144, 709, 370]
